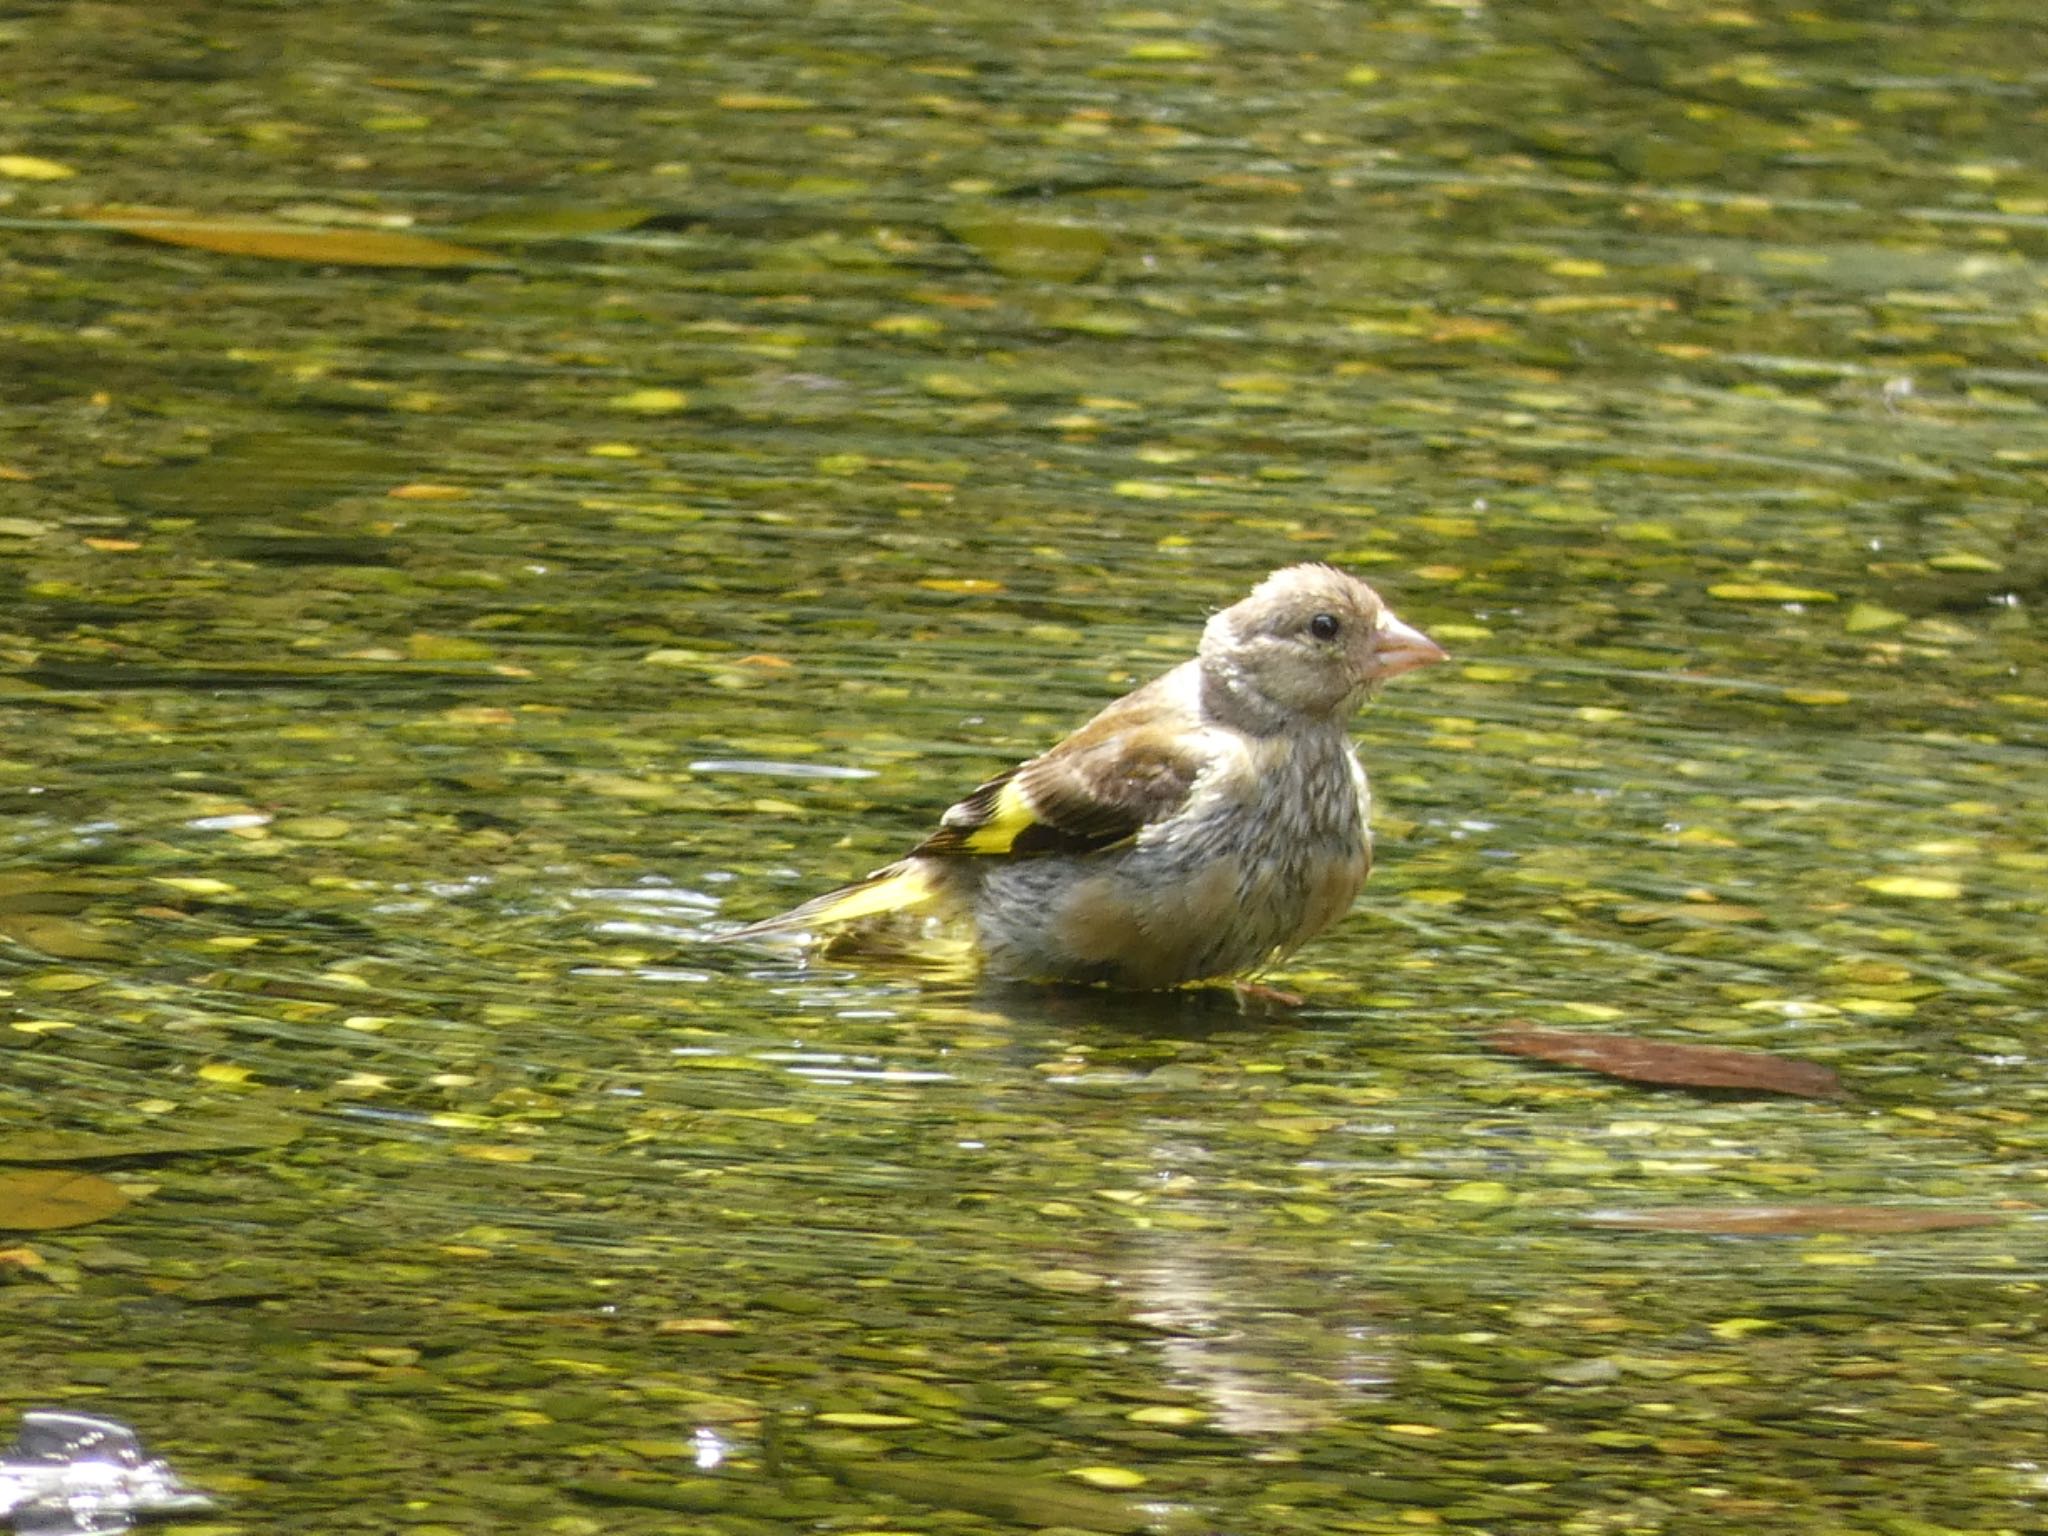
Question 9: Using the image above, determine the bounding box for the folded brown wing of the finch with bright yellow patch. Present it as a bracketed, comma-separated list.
[911, 698, 1202, 858]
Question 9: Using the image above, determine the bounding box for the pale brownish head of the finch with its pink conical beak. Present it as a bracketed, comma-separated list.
[1200, 563, 1444, 729]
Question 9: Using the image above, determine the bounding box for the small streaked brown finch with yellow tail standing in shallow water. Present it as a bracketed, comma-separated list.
[721, 565, 1444, 987]
